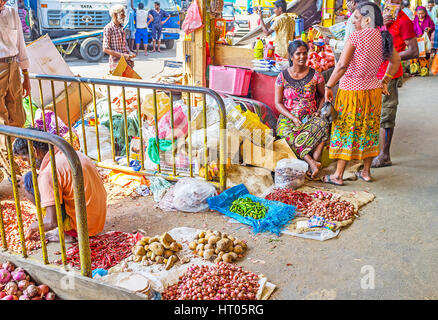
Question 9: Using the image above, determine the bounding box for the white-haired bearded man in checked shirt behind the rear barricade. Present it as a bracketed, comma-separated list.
[103, 5, 136, 73]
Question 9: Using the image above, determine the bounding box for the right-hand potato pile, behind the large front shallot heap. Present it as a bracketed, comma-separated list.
[189, 230, 247, 263]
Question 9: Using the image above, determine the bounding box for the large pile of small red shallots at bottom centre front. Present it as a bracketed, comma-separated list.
[162, 261, 259, 300]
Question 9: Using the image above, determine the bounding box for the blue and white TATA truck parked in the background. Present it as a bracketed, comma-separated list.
[21, 0, 179, 62]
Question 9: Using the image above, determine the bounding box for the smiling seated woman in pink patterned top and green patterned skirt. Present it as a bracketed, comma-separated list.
[275, 40, 329, 178]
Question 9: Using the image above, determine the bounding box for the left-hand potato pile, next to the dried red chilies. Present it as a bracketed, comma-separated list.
[132, 232, 182, 270]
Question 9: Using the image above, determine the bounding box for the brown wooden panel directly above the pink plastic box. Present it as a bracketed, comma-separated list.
[213, 44, 254, 68]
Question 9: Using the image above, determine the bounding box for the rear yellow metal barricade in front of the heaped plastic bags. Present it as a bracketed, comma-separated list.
[30, 74, 226, 191]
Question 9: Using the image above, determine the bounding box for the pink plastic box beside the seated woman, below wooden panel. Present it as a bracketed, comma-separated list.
[210, 66, 252, 96]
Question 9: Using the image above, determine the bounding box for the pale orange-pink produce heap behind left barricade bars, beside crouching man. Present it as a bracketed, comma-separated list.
[0, 201, 41, 253]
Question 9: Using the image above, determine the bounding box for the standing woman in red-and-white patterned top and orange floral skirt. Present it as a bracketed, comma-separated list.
[322, 2, 400, 185]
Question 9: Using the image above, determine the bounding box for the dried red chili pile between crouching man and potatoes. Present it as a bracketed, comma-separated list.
[55, 231, 136, 270]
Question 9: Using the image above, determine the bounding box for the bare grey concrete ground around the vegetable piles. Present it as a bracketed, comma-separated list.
[1, 59, 438, 299]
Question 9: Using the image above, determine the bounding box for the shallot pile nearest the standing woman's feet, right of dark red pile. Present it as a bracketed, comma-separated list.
[303, 199, 356, 221]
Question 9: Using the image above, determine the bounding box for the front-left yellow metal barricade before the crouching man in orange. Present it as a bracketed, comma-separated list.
[0, 125, 91, 277]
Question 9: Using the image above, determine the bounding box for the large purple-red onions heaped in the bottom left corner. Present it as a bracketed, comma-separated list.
[0, 261, 55, 300]
